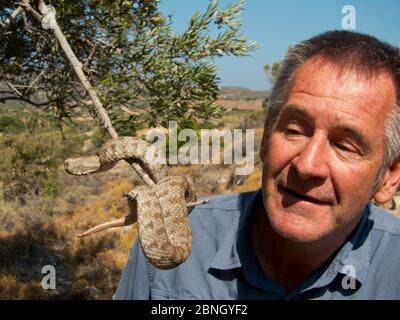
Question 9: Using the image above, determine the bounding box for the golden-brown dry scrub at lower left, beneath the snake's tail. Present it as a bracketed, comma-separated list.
[0, 180, 136, 299]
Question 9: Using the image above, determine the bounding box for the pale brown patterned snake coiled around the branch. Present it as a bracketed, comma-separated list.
[64, 137, 202, 269]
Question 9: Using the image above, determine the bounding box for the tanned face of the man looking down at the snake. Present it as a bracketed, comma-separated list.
[260, 59, 395, 242]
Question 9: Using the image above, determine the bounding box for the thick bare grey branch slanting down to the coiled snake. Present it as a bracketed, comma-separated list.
[34, 0, 155, 188]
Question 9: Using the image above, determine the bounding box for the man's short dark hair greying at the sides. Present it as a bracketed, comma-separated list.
[265, 31, 400, 183]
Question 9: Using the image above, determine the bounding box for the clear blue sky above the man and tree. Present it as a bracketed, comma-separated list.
[160, 0, 400, 90]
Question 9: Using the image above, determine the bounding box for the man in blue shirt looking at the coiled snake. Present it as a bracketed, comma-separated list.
[114, 31, 400, 299]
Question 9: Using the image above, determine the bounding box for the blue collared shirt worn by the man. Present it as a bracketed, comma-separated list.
[114, 190, 400, 300]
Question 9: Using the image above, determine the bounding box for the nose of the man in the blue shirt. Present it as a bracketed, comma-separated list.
[292, 135, 329, 180]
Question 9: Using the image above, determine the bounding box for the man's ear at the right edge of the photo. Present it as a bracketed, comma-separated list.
[374, 161, 400, 203]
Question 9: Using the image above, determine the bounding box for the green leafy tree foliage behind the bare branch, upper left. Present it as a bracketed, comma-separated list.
[0, 0, 257, 135]
